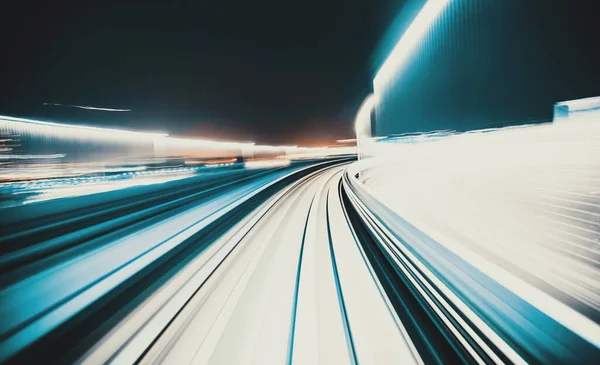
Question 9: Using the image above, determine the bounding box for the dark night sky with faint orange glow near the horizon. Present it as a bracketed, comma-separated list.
[0, 0, 403, 145]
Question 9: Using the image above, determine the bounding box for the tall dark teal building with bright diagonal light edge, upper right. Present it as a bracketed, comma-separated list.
[372, 0, 600, 136]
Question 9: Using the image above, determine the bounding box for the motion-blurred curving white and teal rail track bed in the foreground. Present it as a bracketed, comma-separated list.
[0, 159, 600, 364]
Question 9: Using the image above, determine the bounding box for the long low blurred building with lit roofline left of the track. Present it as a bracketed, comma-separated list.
[0, 116, 322, 174]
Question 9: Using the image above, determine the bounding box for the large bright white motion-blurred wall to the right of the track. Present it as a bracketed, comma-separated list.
[352, 115, 600, 347]
